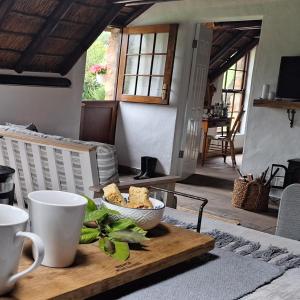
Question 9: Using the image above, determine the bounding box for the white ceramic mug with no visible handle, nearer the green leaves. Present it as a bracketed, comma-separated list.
[28, 191, 87, 268]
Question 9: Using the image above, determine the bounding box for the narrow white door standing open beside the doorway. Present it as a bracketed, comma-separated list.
[180, 24, 212, 177]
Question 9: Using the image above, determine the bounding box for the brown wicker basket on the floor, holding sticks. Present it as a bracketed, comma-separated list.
[232, 179, 270, 211]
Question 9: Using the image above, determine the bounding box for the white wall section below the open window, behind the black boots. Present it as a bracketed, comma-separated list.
[116, 102, 176, 173]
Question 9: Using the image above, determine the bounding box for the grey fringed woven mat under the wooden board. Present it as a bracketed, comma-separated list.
[90, 217, 300, 300]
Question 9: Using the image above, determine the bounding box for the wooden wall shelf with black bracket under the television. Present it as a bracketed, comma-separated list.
[253, 99, 300, 128]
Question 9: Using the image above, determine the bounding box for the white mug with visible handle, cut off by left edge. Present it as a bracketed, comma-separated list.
[0, 204, 44, 295]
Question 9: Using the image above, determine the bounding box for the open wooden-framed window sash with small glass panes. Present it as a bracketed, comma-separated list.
[117, 25, 178, 104]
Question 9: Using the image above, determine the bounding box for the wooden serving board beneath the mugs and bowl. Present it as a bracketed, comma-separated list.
[6, 224, 214, 300]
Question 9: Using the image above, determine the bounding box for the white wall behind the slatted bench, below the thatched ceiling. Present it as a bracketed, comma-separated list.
[0, 57, 85, 138]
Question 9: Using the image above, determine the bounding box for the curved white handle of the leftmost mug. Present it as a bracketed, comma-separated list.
[8, 231, 45, 285]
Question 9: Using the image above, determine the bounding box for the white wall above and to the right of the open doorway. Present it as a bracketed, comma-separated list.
[123, 0, 300, 173]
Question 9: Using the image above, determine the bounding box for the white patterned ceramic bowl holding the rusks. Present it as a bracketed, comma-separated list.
[102, 193, 165, 230]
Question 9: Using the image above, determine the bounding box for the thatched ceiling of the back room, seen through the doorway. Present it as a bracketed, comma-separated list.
[208, 20, 261, 81]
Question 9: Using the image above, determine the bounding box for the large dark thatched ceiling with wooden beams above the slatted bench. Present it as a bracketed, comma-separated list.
[0, 0, 177, 75]
